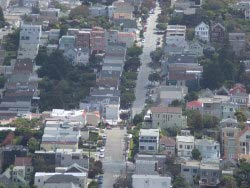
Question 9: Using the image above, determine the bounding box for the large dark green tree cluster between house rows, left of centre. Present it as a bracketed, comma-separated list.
[38, 51, 95, 111]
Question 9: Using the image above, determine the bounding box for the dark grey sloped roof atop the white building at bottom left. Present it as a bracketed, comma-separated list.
[45, 174, 80, 184]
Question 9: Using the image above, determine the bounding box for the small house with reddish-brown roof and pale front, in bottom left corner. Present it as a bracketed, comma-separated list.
[12, 157, 33, 184]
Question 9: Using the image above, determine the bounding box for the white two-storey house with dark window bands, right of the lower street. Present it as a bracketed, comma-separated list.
[139, 129, 160, 153]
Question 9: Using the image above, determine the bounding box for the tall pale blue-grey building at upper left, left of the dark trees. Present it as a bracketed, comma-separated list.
[18, 24, 42, 60]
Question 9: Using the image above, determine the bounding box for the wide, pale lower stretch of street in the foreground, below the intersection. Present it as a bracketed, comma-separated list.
[102, 128, 126, 188]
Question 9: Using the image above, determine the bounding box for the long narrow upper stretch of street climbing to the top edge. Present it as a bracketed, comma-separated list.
[132, 3, 162, 117]
